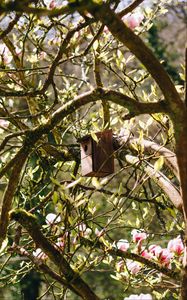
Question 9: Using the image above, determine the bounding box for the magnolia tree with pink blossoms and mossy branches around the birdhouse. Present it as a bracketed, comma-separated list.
[0, 0, 187, 300]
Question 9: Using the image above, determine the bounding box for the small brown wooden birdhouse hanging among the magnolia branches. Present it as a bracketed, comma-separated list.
[80, 130, 114, 177]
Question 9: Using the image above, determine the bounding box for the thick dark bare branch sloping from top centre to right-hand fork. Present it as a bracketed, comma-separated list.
[88, 4, 184, 118]
